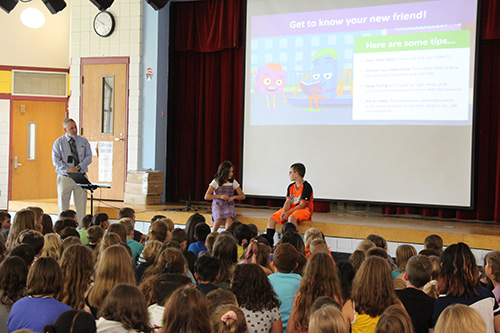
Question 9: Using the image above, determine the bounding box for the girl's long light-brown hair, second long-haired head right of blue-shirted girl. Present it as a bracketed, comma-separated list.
[85, 244, 135, 317]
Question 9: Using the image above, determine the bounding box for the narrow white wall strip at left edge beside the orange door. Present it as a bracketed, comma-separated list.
[0, 99, 10, 209]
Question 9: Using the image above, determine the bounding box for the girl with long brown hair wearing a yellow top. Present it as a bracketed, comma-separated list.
[342, 256, 402, 333]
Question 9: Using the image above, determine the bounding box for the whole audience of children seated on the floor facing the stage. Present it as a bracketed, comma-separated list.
[0, 207, 500, 333]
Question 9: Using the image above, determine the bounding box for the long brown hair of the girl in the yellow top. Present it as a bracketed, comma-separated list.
[351, 257, 399, 317]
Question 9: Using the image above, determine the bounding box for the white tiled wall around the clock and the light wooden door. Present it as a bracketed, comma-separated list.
[69, 0, 143, 170]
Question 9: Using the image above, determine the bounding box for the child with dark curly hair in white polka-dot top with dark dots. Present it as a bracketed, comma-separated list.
[230, 264, 283, 333]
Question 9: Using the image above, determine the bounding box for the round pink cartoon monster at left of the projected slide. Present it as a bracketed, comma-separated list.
[254, 63, 286, 110]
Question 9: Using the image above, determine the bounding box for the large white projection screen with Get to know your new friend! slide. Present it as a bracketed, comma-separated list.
[242, 0, 478, 207]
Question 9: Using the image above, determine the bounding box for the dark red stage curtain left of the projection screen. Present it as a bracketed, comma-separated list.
[166, 0, 244, 201]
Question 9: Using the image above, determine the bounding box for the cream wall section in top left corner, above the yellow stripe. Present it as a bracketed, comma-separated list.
[0, 0, 70, 68]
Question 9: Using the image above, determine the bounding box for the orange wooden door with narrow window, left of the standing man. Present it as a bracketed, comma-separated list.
[10, 100, 66, 200]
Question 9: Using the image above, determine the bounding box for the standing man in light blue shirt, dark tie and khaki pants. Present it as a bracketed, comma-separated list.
[52, 118, 92, 224]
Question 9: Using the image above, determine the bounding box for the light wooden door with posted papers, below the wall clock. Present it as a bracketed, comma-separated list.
[81, 64, 128, 200]
